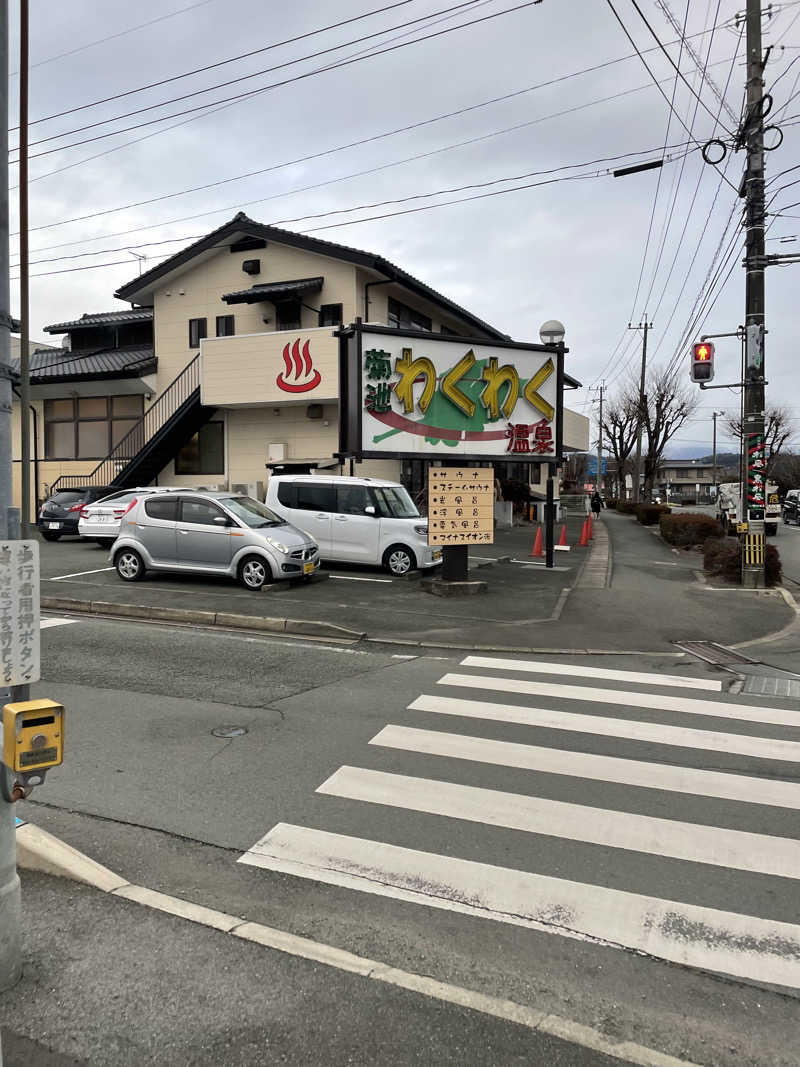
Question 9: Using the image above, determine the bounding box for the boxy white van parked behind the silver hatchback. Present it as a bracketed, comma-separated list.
[265, 475, 442, 575]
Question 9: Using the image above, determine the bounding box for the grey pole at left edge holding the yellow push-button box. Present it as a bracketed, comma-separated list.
[0, 0, 25, 990]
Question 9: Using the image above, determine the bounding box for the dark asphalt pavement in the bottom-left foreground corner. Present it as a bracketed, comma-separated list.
[0, 872, 619, 1067]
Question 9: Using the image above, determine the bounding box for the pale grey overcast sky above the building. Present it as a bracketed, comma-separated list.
[10, 0, 800, 455]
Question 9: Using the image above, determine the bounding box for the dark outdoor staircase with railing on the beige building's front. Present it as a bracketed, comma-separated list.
[50, 352, 215, 493]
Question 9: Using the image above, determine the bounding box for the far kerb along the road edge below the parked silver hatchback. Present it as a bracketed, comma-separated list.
[41, 596, 367, 641]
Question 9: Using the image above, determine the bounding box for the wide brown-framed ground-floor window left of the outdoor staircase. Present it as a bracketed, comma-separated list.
[45, 395, 144, 460]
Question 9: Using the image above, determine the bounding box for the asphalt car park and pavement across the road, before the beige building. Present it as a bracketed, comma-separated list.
[42, 512, 793, 653]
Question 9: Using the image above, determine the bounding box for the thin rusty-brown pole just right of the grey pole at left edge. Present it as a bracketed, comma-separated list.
[19, 0, 29, 538]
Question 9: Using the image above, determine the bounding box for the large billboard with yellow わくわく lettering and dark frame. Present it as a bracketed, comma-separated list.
[340, 323, 563, 462]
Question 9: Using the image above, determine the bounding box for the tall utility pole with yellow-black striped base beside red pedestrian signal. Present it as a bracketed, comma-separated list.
[741, 0, 767, 589]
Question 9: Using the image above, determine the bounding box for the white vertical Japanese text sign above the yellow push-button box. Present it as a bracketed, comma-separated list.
[0, 541, 41, 686]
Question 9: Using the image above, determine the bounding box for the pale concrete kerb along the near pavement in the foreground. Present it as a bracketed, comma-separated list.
[12, 823, 700, 1067]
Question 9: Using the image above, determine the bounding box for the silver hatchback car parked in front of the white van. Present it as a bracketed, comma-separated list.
[111, 490, 319, 589]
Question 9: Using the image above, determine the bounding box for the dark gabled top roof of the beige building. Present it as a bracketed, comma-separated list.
[114, 211, 509, 340]
